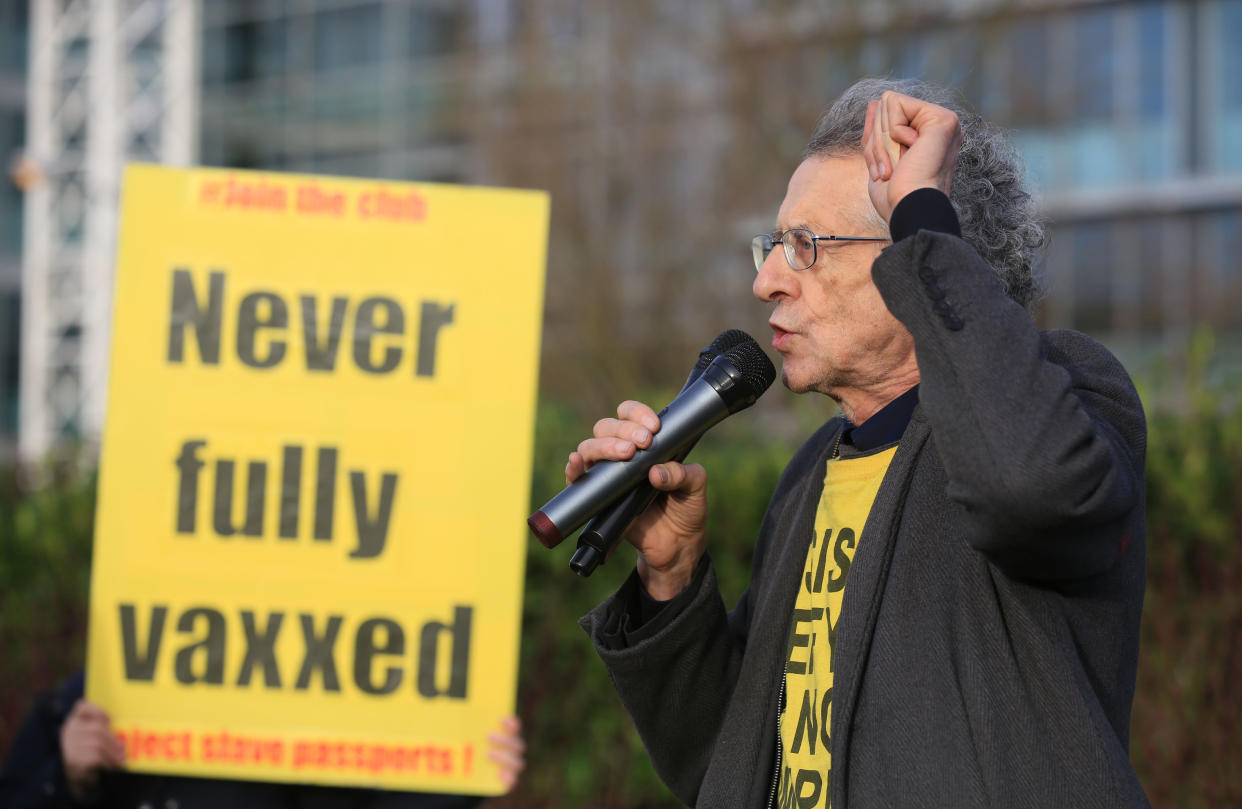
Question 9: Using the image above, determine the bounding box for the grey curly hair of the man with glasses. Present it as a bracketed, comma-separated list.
[802, 78, 1047, 309]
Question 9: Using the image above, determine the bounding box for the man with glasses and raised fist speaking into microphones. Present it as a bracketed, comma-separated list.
[565, 80, 1148, 809]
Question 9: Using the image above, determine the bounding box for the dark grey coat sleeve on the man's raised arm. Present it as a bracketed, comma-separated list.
[872, 231, 1146, 582]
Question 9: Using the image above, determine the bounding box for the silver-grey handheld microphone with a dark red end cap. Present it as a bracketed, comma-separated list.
[527, 339, 776, 548]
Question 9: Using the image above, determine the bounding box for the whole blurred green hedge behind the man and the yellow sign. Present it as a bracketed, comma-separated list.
[0, 350, 1242, 809]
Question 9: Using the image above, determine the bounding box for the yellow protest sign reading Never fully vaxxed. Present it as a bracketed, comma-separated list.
[87, 165, 548, 794]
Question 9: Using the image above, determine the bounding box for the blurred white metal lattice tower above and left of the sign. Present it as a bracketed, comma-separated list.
[19, 0, 199, 459]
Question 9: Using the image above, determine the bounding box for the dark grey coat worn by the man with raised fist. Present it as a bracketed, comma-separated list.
[582, 231, 1148, 809]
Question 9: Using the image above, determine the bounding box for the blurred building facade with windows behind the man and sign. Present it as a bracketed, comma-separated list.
[9, 0, 1242, 454]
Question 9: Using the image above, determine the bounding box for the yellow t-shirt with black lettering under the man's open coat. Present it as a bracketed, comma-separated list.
[776, 446, 897, 809]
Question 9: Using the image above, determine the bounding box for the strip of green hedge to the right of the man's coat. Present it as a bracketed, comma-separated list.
[1130, 333, 1242, 809]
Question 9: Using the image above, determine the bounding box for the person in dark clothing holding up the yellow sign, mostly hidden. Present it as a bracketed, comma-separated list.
[0, 672, 525, 809]
